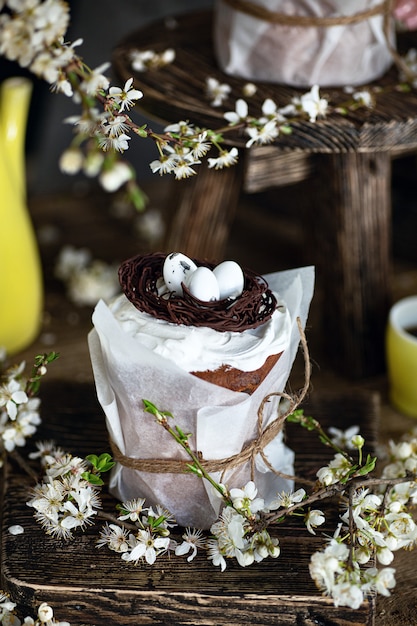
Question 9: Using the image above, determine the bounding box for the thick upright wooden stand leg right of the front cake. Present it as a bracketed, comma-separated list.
[316, 152, 391, 378]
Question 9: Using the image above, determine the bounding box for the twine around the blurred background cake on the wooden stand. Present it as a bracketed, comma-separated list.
[222, 0, 415, 80]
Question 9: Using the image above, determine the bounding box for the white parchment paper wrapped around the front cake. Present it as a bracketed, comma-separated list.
[89, 267, 314, 528]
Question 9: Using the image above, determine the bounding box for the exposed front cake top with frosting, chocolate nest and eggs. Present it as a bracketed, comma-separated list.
[111, 247, 291, 394]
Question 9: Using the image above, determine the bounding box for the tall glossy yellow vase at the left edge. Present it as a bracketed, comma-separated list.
[0, 78, 43, 355]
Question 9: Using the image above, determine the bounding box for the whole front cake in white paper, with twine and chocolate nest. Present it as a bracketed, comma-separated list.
[89, 254, 314, 528]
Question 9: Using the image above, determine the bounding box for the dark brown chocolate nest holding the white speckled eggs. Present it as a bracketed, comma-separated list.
[119, 252, 277, 332]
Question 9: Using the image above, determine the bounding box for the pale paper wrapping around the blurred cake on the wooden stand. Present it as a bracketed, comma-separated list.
[214, 0, 394, 88]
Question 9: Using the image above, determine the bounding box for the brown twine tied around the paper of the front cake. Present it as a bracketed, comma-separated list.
[110, 318, 311, 480]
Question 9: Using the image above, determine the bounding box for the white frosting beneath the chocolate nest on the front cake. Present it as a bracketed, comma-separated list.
[110, 294, 291, 372]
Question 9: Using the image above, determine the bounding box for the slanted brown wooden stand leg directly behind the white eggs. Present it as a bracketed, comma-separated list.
[164, 164, 243, 261]
